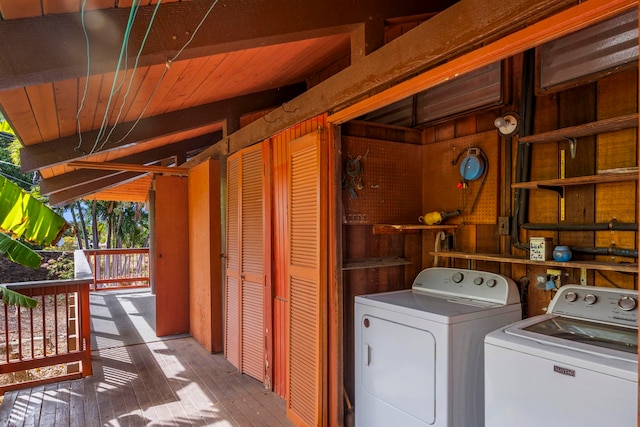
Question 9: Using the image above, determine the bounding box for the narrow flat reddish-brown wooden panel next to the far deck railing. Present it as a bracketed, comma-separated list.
[154, 176, 189, 337]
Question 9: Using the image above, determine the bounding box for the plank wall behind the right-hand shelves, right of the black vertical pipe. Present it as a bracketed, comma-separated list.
[519, 69, 638, 316]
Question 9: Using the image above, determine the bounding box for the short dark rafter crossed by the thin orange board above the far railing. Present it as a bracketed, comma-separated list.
[40, 131, 222, 195]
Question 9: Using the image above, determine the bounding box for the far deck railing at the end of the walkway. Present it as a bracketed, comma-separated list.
[84, 248, 149, 291]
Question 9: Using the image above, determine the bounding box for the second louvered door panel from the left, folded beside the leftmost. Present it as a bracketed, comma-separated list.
[241, 144, 266, 381]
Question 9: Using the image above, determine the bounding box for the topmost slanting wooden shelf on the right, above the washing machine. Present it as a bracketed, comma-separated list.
[518, 113, 638, 144]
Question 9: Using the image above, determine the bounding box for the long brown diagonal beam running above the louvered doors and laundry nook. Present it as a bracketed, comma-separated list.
[182, 0, 592, 165]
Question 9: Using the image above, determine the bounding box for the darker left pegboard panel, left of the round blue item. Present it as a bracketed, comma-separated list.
[342, 136, 424, 224]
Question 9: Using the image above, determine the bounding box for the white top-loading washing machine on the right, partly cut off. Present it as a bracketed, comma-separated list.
[485, 285, 638, 427]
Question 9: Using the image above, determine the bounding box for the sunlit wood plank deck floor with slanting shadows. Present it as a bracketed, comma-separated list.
[0, 291, 292, 427]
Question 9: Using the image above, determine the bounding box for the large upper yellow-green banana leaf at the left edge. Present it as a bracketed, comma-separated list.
[0, 176, 69, 246]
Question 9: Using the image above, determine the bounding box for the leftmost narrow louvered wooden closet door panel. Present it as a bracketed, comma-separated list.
[224, 153, 242, 369]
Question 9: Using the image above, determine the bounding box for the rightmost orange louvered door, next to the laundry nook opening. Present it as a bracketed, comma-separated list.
[287, 132, 327, 426]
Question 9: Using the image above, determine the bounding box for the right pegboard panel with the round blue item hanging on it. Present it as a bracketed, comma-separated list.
[424, 131, 500, 224]
